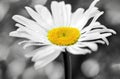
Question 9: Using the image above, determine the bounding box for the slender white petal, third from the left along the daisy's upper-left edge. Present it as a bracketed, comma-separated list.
[25, 7, 50, 30]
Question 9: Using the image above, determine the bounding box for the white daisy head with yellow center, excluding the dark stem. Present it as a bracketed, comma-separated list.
[10, 0, 116, 69]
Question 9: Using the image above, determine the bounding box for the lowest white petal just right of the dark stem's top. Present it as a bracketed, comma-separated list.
[67, 46, 91, 55]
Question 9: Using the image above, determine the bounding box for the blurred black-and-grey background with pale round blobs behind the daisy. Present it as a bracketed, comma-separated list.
[0, 0, 120, 79]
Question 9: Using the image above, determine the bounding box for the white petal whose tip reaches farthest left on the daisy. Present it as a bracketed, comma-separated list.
[9, 28, 49, 43]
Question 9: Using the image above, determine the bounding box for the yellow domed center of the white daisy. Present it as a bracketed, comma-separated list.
[48, 27, 80, 46]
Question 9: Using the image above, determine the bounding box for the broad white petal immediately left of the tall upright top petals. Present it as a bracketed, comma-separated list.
[35, 5, 53, 29]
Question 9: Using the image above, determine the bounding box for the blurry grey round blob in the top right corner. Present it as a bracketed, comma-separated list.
[105, 0, 120, 25]
